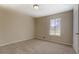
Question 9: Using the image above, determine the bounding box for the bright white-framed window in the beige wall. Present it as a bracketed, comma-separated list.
[50, 18, 61, 36]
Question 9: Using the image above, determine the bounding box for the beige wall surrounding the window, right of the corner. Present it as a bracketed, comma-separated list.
[35, 11, 73, 45]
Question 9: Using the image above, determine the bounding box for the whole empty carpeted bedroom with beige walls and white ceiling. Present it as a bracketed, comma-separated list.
[0, 4, 79, 54]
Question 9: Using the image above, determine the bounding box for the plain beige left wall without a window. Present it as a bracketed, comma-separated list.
[0, 7, 34, 46]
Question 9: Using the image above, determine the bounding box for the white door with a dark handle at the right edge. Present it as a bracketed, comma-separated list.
[73, 4, 79, 53]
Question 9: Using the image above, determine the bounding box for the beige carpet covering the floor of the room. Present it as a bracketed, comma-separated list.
[0, 39, 75, 54]
